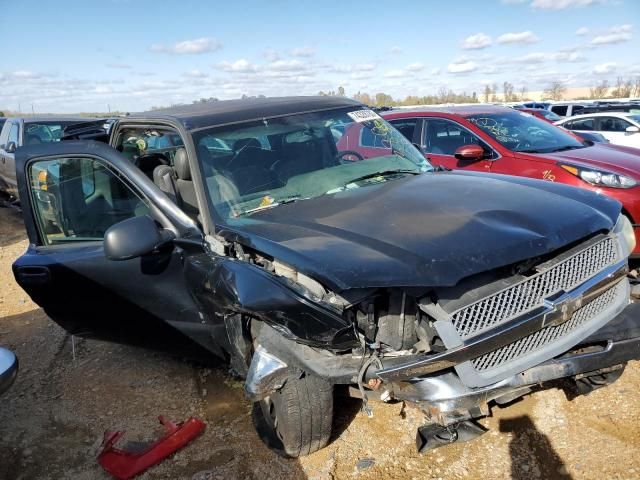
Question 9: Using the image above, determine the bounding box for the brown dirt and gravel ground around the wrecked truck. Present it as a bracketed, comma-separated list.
[0, 202, 640, 480]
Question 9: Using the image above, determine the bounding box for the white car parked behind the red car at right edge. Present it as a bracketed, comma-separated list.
[556, 112, 640, 148]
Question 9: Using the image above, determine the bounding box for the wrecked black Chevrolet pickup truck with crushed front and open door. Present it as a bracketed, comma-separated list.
[13, 97, 640, 457]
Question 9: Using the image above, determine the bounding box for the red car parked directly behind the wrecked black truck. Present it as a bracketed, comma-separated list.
[382, 105, 640, 256]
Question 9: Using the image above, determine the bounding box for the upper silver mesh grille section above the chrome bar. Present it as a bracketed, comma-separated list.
[451, 237, 618, 339]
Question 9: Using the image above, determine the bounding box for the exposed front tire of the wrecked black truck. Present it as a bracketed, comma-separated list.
[253, 375, 333, 457]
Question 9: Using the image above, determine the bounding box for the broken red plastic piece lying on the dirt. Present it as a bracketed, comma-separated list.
[98, 416, 205, 480]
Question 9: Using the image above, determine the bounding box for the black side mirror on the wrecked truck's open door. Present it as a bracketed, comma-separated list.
[104, 215, 174, 260]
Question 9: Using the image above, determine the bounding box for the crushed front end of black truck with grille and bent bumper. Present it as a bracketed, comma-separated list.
[247, 217, 640, 451]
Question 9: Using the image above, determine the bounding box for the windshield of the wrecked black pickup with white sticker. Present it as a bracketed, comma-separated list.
[194, 107, 432, 219]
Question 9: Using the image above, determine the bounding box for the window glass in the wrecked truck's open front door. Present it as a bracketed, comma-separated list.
[28, 157, 149, 245]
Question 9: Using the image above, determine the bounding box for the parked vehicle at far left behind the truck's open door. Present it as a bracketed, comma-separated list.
[0, 117, 87, 198]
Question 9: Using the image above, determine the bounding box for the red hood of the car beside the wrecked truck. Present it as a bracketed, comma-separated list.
[516, 143, 640, 180]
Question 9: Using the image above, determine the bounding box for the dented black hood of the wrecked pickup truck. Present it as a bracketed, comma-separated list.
[218, 172, 620, 292]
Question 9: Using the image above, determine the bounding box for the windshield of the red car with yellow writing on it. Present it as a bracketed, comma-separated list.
[467, 111, 586, 153]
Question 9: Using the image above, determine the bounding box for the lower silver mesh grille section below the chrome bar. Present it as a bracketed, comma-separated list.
[471, 280, 626, 372]
